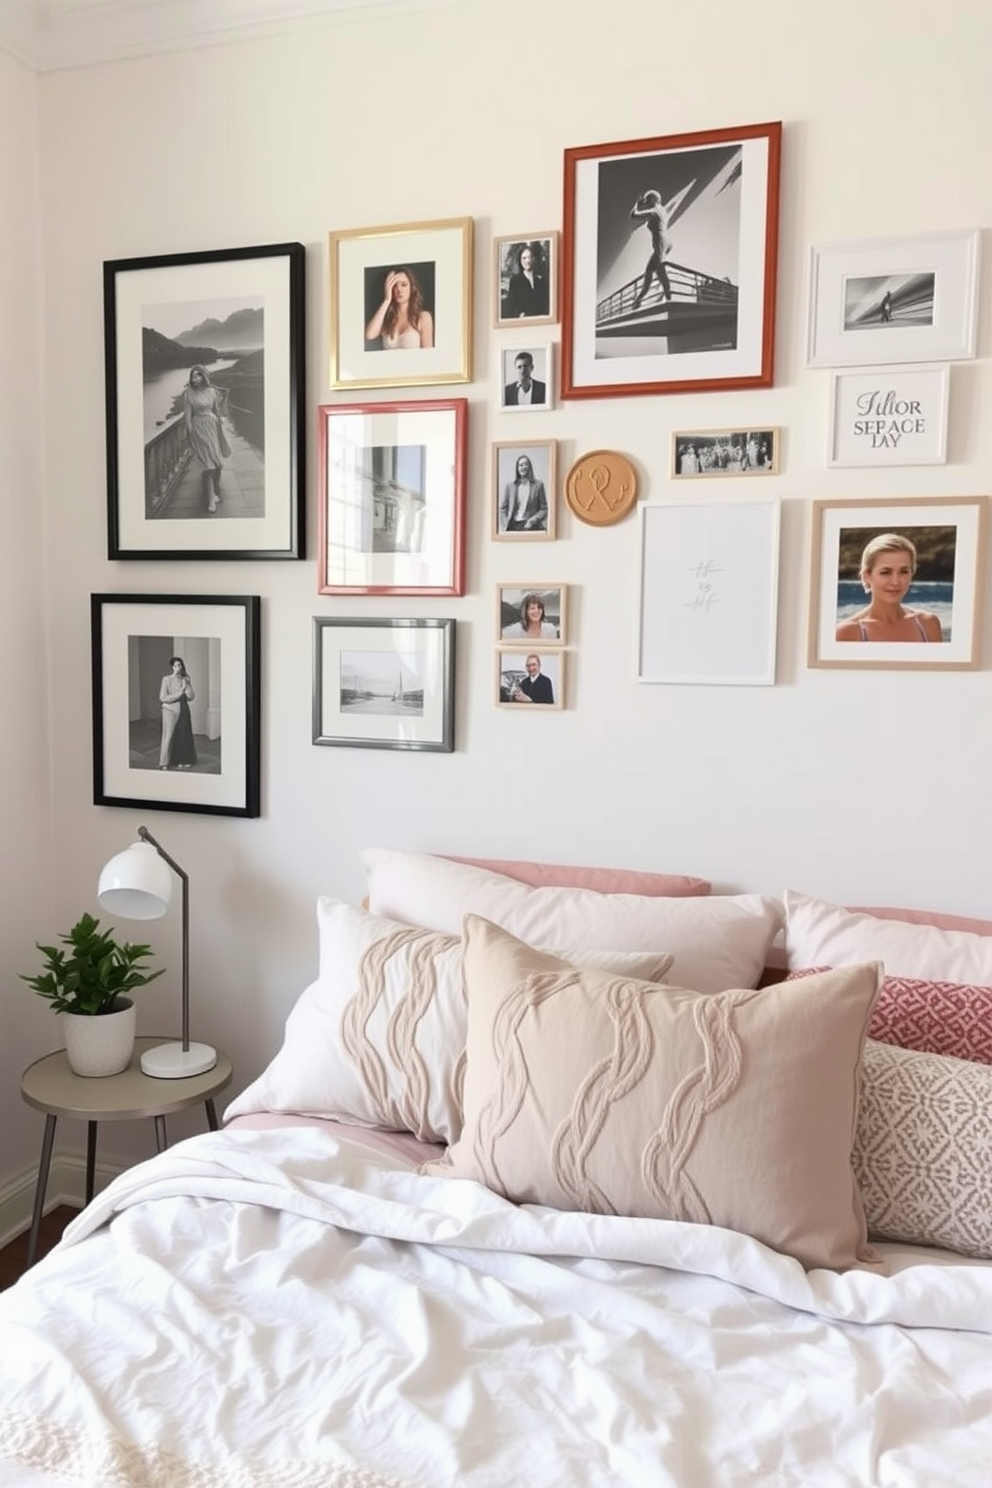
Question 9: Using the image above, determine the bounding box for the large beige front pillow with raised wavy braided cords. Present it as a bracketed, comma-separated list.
[424, 915, 880, 1268]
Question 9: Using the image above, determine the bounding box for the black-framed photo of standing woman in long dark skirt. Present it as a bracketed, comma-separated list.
[91, 594, 262, 817]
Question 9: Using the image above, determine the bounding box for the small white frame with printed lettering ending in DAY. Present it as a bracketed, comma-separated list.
[827, 362, 950, 466]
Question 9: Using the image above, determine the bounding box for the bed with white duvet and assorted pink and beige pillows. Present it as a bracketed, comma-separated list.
[0, 850, 992, 1488]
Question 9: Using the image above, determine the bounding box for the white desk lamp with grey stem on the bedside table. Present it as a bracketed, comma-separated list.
[97, 827, 217, 1080]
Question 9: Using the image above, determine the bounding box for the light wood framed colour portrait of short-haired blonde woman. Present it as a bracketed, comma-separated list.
[808, 496, 986, 671]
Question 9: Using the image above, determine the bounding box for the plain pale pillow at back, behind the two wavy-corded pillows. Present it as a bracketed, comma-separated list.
[361, 848, 782, 992]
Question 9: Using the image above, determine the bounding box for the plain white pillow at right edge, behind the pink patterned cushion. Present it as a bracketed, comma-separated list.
[785, 888, 992, 987]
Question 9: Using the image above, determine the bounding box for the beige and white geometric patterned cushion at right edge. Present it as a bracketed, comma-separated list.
[851, 1039, 992, 1260]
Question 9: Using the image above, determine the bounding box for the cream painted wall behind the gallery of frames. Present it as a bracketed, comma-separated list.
[3, 0, 992, 1184]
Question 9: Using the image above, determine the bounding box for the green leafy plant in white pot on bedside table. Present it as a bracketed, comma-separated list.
[21, 914, 164, 1076]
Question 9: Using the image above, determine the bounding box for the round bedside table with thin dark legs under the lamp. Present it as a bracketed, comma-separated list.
[21, 1037, 232, 1266]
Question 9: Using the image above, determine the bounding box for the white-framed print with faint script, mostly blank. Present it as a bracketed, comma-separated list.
[637, 498, 781, 686]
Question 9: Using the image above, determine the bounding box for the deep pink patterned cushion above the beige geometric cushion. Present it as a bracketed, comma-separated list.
[790, 967, 992, 1064]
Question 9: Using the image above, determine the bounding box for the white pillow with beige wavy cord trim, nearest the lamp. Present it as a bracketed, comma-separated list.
[225, 899, 672, 1141]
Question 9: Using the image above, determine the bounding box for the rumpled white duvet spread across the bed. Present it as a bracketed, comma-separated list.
[0, 1128, 992, 1488]
